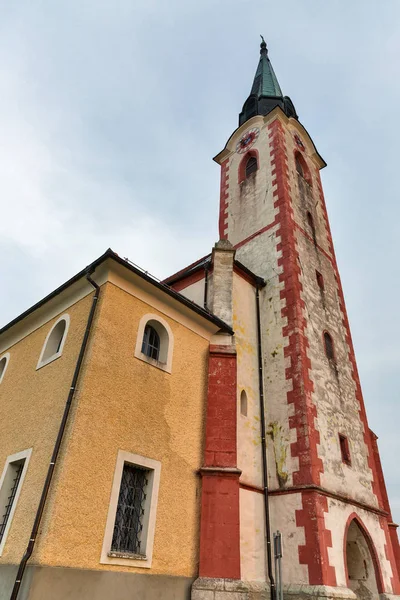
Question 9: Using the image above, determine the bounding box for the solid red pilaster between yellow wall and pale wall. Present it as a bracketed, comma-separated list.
[199, 346, 240, 579]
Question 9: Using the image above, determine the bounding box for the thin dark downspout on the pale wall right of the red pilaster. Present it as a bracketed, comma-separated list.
[256, 284, 276, 600]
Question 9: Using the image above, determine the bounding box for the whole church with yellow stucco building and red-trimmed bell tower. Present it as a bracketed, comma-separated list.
[0, 40, 400, 600]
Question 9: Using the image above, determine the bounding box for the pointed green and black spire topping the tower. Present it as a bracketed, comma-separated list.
[239, 36, 297, 125]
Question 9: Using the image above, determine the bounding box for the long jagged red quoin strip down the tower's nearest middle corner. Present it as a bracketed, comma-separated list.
[268, 119, 336, 585]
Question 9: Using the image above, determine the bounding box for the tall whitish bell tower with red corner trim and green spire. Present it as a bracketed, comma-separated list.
[215, 40, 400, 599]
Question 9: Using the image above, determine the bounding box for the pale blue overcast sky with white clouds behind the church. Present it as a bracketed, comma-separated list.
[0, 0, 400, 521]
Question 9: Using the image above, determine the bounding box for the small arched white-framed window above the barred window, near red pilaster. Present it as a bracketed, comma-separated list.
[135, 314, 174, 373]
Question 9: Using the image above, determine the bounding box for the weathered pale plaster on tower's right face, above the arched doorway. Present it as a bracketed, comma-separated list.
[286, 129, 377, 505]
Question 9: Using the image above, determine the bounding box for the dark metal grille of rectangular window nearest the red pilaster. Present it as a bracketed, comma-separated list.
[111, 464, 148, 554]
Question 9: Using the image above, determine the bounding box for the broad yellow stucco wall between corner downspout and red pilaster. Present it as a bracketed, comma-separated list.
[33, 283, 209, 576]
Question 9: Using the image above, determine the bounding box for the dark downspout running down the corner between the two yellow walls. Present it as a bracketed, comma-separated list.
[10, 273, 100, 600]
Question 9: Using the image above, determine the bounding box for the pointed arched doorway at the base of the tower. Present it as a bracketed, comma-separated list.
[345, 515, 383, 600]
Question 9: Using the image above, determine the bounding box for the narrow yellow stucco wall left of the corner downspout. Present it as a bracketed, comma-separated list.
[0, 296, 95, 565]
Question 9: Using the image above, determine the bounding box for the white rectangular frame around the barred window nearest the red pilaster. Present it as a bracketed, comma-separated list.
[100, 450, 161, 569]
